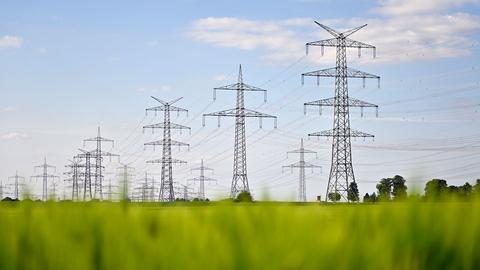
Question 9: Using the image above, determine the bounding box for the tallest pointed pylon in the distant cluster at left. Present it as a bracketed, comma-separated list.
[83, 127, 118, 200]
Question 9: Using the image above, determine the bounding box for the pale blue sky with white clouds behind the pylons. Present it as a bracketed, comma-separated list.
[0, 0, 480, 200]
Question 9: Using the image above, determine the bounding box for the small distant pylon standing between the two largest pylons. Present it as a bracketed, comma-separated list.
[282, 138, 322, 202]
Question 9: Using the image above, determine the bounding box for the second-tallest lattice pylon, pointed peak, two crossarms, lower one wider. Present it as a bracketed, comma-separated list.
[203, 65, 277, 198]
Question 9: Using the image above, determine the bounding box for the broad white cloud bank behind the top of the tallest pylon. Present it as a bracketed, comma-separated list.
[187, 0, 480, 63]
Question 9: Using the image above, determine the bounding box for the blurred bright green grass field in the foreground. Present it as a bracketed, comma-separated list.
[0, 202, 480, 270]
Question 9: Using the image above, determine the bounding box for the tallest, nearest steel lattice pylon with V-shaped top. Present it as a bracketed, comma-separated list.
[302, 21, 380, 201]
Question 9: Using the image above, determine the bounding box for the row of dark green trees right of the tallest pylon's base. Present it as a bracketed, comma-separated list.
[362, 175, 480, 202]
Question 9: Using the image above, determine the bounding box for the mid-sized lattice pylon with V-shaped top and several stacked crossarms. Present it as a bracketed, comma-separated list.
[143, 96, 190, 202]
